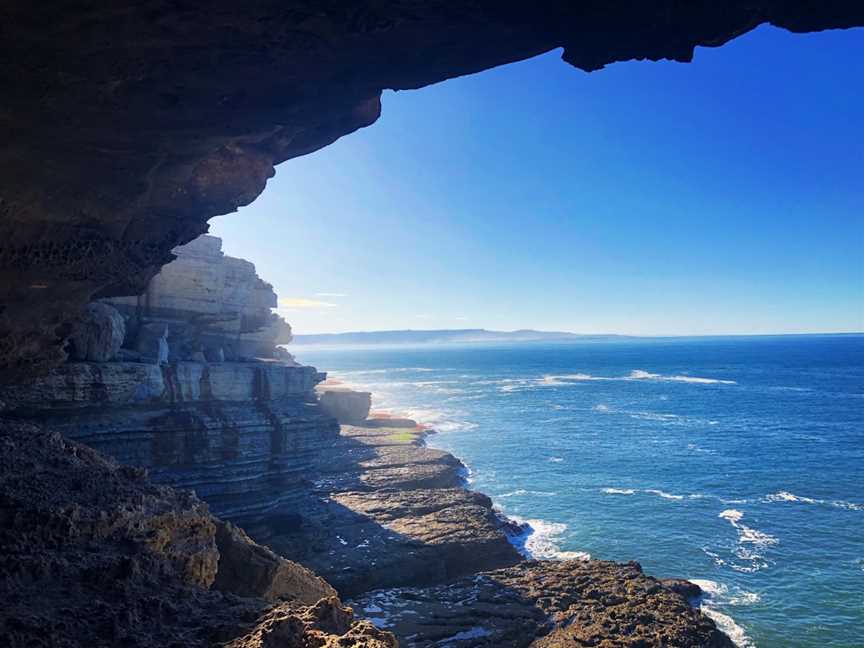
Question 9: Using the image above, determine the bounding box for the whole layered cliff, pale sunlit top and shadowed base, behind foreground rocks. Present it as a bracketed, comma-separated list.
[0, 236, 330, 537]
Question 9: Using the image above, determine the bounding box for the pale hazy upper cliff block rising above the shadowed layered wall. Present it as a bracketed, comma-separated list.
[106, 236, 291, 362]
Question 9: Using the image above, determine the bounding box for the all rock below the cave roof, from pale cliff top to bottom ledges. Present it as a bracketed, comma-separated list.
[0, 237, 744, 648]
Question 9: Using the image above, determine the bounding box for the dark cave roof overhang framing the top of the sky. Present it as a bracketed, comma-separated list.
[0, 0, 864, 382]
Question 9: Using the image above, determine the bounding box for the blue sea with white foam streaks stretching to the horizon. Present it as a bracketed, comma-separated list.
[293, 336, 864, 648]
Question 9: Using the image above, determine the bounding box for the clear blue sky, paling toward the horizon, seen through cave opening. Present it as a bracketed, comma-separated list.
[211, 27, 864, 335]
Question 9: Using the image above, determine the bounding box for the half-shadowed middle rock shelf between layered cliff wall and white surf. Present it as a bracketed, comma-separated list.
[268, 424, 520, 596]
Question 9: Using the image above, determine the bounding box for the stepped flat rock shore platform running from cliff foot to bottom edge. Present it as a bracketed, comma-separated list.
[292, 381, 734, 648]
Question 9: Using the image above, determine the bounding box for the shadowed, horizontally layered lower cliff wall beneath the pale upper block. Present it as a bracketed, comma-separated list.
[0, 362, 339, 536]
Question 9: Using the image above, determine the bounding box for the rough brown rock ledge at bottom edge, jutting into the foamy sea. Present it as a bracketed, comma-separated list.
[353, 560, 734, 648]
